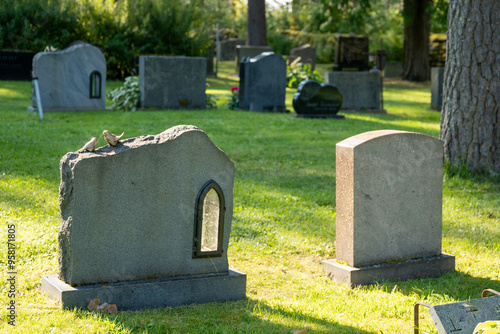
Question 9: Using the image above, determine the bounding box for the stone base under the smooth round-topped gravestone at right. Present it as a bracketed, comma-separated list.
[323, 253, 455, 287]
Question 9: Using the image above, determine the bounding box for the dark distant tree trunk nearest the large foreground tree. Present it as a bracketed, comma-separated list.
[403, 0, 432, 81]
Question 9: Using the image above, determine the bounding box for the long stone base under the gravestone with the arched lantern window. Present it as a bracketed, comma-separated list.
[41, 269, 246, 311]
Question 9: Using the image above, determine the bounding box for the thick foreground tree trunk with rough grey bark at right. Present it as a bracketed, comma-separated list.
[441, 0, 500, 173]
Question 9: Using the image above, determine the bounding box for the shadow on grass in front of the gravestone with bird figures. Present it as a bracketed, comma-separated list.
[92, 299, 374, 334]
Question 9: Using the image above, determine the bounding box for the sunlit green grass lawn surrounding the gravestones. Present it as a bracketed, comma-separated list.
[0, 62, 500, 334]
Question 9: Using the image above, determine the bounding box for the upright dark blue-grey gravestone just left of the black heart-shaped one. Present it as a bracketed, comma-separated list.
[238, 52, 287, 111]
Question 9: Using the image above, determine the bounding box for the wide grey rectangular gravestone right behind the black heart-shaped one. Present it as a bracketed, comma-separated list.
[325, 71, 385, 113]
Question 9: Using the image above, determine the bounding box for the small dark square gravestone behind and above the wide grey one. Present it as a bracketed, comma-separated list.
[333, 35, 370, 71]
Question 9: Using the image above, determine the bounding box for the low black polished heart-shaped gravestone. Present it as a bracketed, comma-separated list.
[293, 80, 344, 118]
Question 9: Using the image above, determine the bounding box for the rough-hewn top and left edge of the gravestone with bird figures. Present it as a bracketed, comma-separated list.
[57, 125, 232, 284]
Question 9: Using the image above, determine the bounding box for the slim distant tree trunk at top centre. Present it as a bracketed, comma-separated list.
[247, 0, 267, 46]
